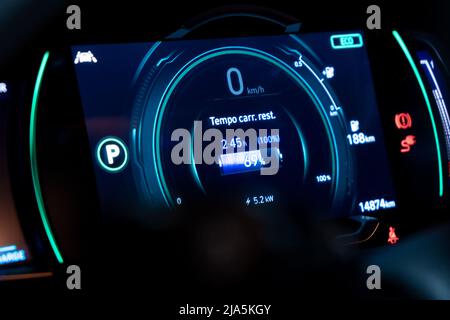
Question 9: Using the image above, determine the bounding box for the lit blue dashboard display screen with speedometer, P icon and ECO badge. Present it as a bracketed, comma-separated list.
[72, 31, 395, 219]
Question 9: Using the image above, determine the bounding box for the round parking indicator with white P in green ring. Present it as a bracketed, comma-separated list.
[96, 137, 128, 173]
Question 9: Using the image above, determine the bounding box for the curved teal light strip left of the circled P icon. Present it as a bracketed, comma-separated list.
[30, 51, 64, 263]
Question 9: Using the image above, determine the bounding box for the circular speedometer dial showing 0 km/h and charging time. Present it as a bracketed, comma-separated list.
[134, 38, 352, 219]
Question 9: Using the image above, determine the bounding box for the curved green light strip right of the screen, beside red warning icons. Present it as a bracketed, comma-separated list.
[392, 30, 444, 197]
